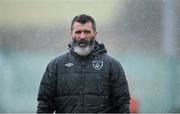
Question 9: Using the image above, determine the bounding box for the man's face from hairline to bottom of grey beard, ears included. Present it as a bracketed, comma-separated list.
[71, 22, 97, 56]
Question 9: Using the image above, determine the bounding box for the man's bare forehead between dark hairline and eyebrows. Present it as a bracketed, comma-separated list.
[73, 22, 93, 30]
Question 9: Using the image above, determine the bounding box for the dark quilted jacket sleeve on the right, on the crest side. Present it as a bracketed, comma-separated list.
[110, 61, 130, 113]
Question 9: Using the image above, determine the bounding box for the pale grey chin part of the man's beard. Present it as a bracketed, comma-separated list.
[74, 46, 92, 56]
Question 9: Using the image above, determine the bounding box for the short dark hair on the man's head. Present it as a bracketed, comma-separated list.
[71, 14, 96, 31]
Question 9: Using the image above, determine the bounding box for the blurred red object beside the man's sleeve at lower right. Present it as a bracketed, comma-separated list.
[130, 96, 139, 113]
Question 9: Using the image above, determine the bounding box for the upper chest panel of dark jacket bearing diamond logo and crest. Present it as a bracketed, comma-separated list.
[57, 57, 110, 74]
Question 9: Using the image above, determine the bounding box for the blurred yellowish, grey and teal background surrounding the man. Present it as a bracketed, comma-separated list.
[0, 0, 180, 113]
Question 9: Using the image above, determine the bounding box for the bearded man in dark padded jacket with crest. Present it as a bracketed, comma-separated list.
[37, 14, 130, 113]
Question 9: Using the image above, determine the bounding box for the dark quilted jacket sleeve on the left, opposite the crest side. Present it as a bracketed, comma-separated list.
[37, 61, 56, 113]
